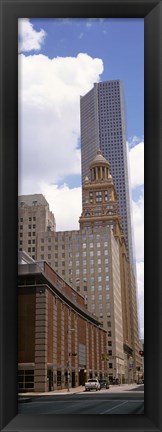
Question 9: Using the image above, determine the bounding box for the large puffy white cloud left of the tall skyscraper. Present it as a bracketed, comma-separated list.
[19, 53, 103, 193]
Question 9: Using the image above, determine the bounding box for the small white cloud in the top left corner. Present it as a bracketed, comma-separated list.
[18, 18, 46, 52]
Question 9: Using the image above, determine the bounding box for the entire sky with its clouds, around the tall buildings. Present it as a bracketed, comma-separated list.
[19, 18, 144, 337]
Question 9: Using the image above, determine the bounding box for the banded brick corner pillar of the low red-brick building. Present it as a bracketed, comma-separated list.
[34, 287, 48, 392]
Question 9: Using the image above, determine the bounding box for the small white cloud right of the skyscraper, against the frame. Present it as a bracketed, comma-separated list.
[129, 142, 144, 189]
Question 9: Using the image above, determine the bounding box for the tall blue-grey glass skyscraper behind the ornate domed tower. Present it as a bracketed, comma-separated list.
[80, 80, 133, 266]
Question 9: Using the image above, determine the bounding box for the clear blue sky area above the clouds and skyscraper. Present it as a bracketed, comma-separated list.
[30, 18, 144, 137]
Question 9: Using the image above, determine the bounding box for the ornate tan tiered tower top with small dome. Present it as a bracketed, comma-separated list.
[79, 150, 123, 246]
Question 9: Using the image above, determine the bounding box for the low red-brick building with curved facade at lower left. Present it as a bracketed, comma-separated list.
[18, 253, 107, 392]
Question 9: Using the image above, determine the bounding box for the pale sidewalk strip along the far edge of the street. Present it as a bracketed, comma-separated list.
[18, 383, 138, 399]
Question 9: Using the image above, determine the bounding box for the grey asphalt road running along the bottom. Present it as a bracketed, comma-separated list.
[18, 386, 144, 415]
